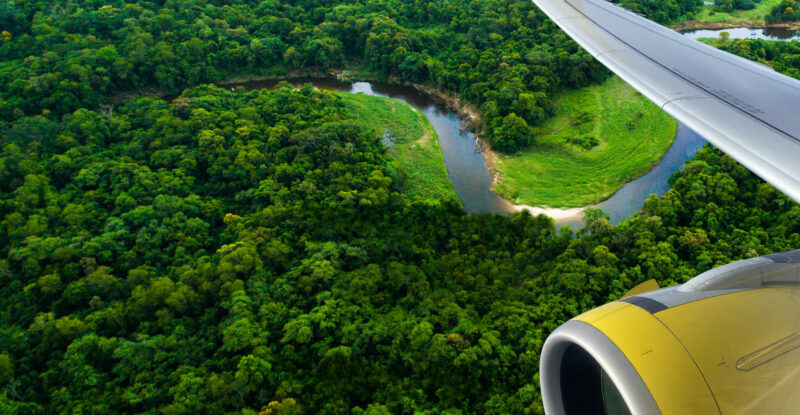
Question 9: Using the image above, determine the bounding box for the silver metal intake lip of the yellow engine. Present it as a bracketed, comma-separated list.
[539, 320, 661, 415]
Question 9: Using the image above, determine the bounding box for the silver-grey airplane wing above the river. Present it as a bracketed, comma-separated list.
[533, 0, 800, 202]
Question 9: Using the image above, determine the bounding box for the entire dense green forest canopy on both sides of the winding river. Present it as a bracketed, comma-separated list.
[0, 0, 800, 415]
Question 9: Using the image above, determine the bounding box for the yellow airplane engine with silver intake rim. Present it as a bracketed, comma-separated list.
[540, 250, 800, 415]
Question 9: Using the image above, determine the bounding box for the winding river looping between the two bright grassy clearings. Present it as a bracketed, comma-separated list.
[226, 78, 705, 229]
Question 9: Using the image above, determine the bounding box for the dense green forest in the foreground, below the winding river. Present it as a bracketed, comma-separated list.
[0, 86, 800, 414]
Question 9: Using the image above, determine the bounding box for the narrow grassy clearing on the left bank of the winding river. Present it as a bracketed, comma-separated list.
[338, 93, 460, 203]
